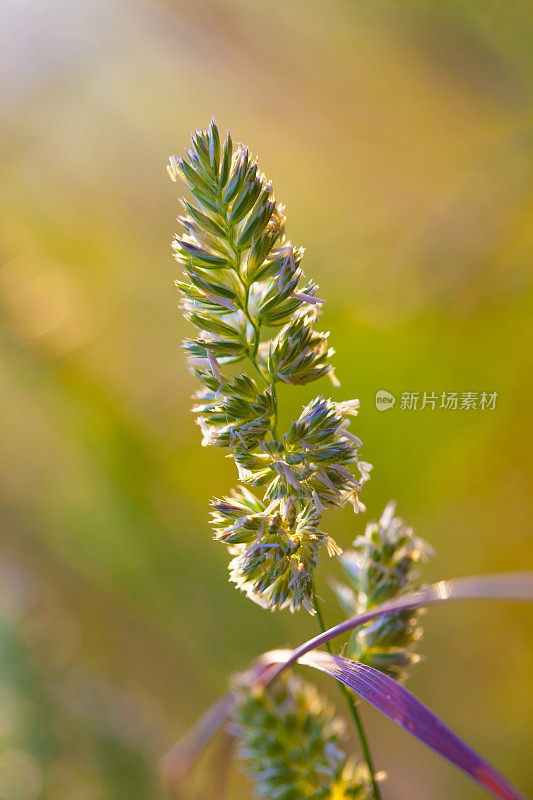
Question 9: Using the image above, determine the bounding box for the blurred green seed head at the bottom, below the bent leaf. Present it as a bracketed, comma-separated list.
[232, 673, 371, 800]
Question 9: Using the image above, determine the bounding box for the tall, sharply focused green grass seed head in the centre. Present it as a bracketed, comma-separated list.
[169, 120, 370, 613]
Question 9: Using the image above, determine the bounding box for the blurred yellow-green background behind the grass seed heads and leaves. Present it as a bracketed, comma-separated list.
[0, 0, 533, 800]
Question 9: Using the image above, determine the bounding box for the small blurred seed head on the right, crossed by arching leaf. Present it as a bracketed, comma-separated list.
[333, 503, 433, 682]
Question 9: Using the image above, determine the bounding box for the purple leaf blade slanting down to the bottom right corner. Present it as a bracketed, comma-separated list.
[263, 650, 525, 800]
